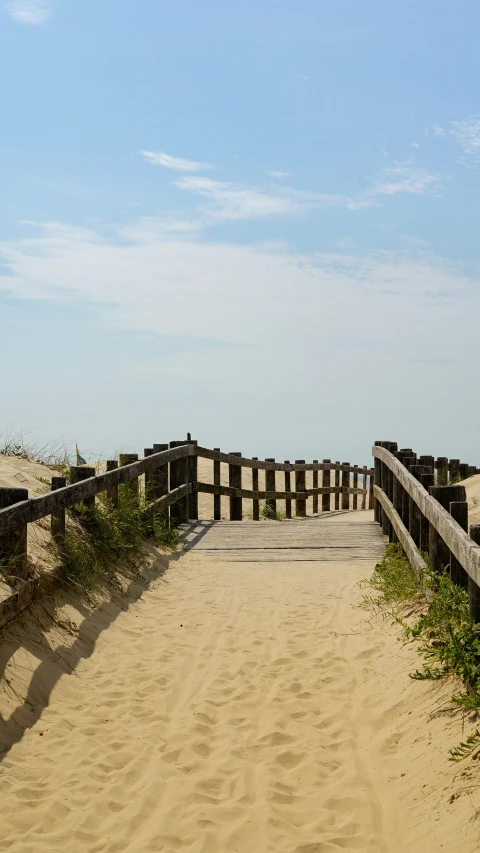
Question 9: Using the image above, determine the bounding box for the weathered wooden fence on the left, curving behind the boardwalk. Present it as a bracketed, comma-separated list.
[0, 436, 373, 579]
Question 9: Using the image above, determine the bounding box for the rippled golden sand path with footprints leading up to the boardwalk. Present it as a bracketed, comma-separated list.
[0, 513, 480, 853]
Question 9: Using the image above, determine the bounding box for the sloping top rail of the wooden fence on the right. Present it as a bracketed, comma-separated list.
[372, 445, 480, 585]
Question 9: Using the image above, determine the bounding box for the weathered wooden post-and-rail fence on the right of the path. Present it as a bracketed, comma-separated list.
[373, 441, 480, 622]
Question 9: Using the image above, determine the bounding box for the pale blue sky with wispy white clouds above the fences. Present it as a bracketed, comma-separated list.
[0, 0, 480, 464]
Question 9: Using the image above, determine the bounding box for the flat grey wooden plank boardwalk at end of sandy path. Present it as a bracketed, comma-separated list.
[182, 511, 385, 563]
